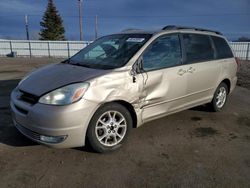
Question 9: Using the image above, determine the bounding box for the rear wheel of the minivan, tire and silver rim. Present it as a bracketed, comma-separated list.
[210, 82, 228, 112]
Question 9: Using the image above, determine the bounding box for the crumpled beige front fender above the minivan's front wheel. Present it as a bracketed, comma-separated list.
[84, 69, 142, 126]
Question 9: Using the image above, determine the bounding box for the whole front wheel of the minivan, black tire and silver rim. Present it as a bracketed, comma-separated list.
[87, 103, 133, 153]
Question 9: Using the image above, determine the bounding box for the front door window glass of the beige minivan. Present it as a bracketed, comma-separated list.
[142, 34, 181, 71]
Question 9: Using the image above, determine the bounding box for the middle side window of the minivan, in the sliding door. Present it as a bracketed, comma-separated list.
[183, 34, 215, 63]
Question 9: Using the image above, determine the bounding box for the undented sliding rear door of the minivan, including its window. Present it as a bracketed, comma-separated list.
[182, 33, 221, 106]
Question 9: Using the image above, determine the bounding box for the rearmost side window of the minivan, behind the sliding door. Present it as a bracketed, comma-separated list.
[212, 36, 233, 59]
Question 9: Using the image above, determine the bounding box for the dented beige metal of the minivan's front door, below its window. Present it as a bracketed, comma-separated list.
[138, 66, 187, 122]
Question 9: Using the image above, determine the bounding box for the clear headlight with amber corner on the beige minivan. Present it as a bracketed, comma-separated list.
[39, 83, 89, 105]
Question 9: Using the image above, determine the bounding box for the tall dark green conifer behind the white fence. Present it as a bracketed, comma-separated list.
[39, 0, 65, 40]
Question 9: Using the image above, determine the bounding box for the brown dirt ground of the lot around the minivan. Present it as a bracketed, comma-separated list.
[0, 58, 250, 188]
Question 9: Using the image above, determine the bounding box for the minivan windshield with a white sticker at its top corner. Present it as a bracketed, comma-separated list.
[68, 34, 152, 69]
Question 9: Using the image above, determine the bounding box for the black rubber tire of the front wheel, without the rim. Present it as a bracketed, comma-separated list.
[87, 103, 133, 153]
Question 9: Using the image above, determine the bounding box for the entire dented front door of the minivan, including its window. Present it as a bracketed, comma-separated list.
[140, 34, 187, 122]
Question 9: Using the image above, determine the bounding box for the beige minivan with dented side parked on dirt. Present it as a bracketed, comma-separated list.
[10, 26, 239, 152]
